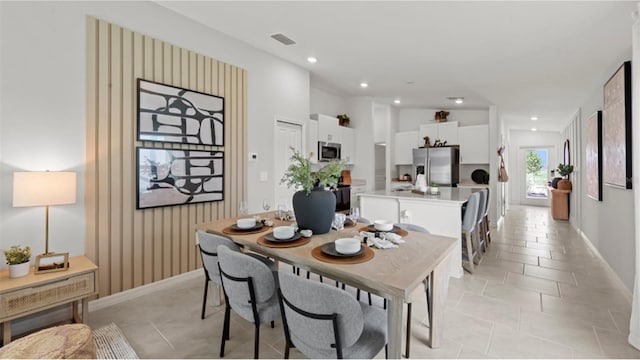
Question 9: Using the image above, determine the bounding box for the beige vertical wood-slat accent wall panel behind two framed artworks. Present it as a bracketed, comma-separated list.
[85, 17, 247, 296]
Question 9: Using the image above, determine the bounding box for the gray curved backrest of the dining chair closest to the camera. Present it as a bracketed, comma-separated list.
[278, 272, 364, 351]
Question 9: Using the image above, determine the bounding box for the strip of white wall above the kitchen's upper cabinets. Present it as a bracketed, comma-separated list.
[396, 109, 489, 132]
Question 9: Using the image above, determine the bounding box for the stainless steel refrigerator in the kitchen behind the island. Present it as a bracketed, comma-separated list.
[413, 145, 460, 187]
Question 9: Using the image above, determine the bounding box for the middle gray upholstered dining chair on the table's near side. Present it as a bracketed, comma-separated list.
[218, 245, 280, 359]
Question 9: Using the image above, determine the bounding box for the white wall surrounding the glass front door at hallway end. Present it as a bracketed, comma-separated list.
[506, 130, 564, 204]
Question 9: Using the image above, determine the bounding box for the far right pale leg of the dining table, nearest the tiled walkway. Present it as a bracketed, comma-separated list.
[429, 250, 451, 349]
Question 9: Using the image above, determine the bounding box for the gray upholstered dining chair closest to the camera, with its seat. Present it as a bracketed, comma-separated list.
[278, 273, 387, 359]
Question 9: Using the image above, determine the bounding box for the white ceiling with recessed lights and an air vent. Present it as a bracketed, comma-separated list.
[159, 1, 637, 130]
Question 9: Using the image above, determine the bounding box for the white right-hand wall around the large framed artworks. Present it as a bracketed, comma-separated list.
[568, 44, 640, 291]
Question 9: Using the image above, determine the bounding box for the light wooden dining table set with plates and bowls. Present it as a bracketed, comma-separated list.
[197, 214, 457, 359]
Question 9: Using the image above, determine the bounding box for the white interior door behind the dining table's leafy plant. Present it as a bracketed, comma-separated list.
[272, 120, 304, 210]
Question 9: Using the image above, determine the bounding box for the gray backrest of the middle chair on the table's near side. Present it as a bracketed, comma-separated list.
[218, 245, 277, 322]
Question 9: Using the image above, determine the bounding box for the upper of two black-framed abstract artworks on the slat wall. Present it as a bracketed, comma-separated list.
[138, 79, 224, 146]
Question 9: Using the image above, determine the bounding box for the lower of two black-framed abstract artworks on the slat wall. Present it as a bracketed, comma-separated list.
[136, 147, 224, 209]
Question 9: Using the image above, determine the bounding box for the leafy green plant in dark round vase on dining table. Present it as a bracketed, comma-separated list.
[280, 148, 344, 234]
